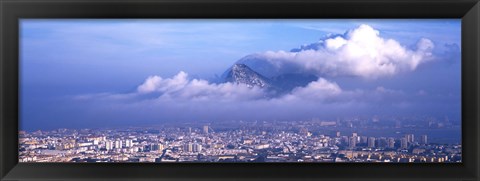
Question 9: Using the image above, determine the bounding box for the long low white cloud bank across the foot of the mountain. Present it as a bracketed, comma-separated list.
[79, 72, 404, 104]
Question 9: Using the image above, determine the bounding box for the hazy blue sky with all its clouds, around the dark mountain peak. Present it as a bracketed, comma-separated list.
[20, 19, 461, 130]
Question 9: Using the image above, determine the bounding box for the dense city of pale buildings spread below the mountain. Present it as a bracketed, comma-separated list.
[19, 116, 462, 163]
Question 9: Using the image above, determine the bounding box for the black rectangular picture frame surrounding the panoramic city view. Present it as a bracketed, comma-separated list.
[0, 0, 480, 181]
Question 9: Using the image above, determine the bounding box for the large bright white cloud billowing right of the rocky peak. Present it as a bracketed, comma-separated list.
[261, 25, 434, 79]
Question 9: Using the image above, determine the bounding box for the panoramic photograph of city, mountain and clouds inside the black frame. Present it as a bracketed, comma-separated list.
[18, 19, 462, 164]
